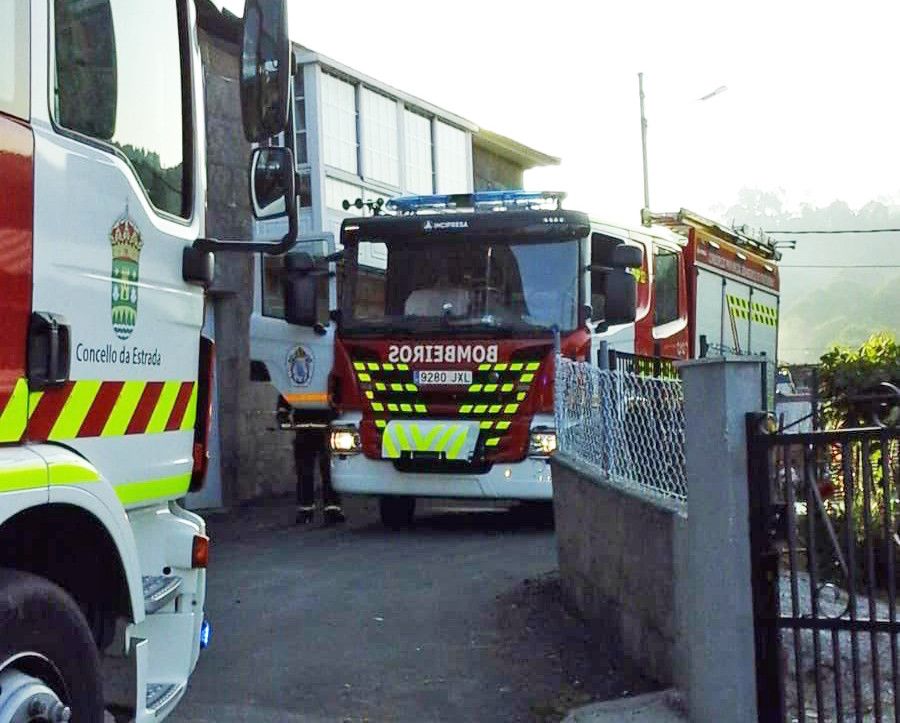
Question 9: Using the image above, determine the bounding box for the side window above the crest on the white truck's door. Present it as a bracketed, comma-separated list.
[52, 0, 192, 218]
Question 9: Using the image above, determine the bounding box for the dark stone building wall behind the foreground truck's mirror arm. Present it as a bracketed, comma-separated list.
[201, 26, 295, 505]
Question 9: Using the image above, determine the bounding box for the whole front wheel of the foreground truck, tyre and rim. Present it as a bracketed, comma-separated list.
[0, 569, 104, 723]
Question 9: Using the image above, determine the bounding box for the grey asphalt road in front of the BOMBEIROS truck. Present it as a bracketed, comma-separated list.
[170, 501, 648, 723]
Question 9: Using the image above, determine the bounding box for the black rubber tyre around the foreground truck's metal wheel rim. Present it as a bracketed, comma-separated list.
[0, 569, 104, 723]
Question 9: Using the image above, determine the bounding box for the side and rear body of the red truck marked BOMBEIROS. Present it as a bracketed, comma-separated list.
[592, 209, 780, 376]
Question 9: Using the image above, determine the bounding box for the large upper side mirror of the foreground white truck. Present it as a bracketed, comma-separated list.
[241, 0, 291, 143]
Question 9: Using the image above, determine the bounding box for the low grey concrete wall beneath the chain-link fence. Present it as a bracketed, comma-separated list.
[551, 454, 687, 688]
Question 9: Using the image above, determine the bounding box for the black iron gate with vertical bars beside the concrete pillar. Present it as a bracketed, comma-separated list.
[747, 414, 900, 723]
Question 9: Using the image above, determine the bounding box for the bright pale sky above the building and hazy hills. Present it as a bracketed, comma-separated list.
[225, 0, 900, 224]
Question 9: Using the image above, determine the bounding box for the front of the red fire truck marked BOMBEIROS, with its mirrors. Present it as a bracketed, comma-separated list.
[282, 192, 641, 525]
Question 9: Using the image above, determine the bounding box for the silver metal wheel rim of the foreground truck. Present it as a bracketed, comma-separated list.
[0, 653, 72, 723]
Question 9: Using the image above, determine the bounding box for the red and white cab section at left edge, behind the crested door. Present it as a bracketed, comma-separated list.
[0, 2, 34, 446]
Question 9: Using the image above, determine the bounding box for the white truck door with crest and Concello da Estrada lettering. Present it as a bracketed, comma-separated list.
[28, 0, 205, 504]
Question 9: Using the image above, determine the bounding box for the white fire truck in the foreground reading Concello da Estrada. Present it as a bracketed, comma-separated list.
[0, 0, 296, 723]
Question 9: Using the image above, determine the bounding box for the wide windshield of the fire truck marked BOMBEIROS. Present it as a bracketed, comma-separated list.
[343, 239, 579, 335]
